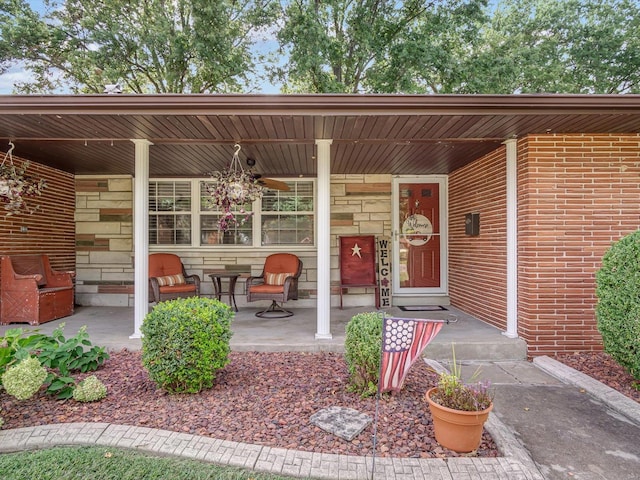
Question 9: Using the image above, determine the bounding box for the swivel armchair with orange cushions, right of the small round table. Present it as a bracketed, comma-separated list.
[247, 253, 302, 318]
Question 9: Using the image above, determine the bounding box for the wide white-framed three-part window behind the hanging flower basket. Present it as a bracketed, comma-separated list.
[149, 179, 315, 247]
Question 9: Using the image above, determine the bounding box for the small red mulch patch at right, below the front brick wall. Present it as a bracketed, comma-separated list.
[556, 352, 640, 403]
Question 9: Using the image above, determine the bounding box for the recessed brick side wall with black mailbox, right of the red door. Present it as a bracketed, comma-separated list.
[449, 147, 507, 329]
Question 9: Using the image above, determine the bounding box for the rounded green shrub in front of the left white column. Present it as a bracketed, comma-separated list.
[141, 297, 233, 393]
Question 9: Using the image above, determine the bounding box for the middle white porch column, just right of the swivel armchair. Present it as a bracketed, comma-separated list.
[316, 140, 333, 340]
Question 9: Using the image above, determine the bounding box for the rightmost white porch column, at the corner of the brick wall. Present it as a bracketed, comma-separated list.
[503, 139, 518, 338]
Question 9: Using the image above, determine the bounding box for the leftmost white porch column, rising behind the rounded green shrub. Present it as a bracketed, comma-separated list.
[130, 139, 153, 338]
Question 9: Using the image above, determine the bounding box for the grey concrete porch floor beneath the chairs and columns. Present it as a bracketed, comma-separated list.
[0, 302, 527, 361]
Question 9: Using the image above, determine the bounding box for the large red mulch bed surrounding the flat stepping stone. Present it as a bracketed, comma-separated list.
[0, 350, 499, 458]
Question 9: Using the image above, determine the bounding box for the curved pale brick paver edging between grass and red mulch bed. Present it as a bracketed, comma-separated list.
[0, 420, 542, 480]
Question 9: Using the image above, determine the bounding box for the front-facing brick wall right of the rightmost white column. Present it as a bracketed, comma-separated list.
[518, 134, 640, 356]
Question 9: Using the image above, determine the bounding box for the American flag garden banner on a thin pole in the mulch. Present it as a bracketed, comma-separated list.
[378, 317, 447, 393]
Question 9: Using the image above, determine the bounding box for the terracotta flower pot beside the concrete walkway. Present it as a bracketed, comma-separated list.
[425, 387, 493, 453]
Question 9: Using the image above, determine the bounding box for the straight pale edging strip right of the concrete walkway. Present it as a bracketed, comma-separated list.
[533, 355, 640, 425]
